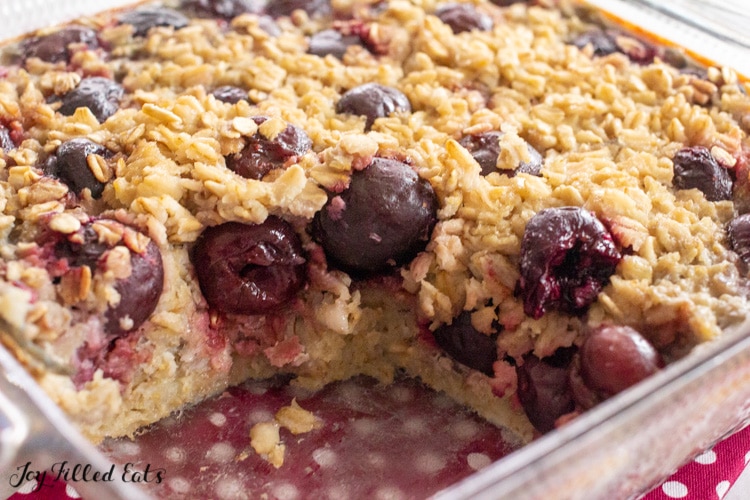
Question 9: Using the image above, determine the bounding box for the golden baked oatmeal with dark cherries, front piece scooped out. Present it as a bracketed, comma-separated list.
[0, 0, 750, 443]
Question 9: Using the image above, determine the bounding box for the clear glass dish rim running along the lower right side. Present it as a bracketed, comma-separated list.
[436, 318, 750, 500]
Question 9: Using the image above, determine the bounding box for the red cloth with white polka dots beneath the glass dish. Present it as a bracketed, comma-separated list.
[5, 379, 750, 500]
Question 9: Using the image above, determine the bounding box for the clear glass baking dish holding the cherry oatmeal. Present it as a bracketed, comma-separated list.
[0, 0, 750, 499]
